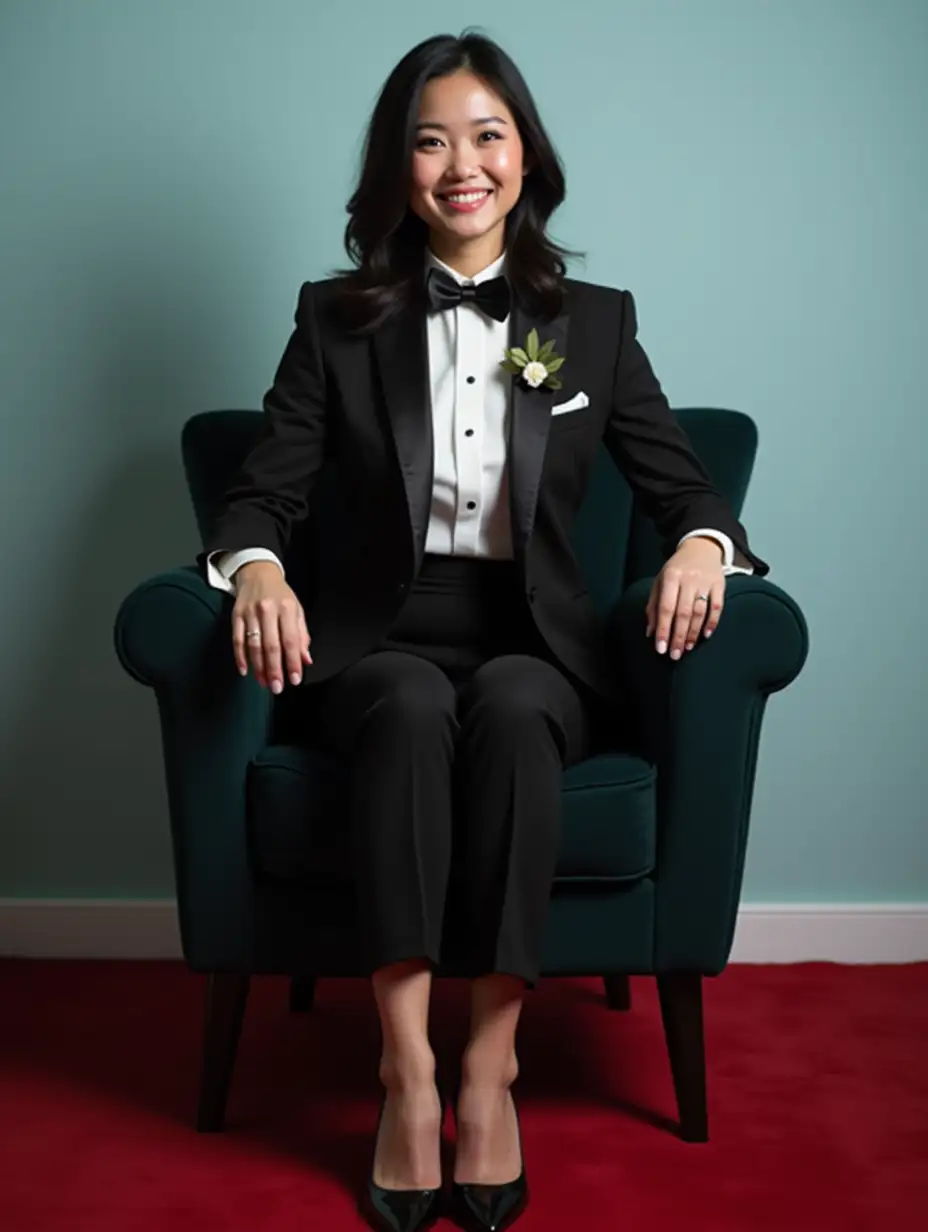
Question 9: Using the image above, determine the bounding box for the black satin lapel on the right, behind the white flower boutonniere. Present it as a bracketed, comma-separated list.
[509, 299, 571, 562]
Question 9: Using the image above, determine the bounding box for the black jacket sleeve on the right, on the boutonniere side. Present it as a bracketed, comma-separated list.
[603, 291, 769, 577]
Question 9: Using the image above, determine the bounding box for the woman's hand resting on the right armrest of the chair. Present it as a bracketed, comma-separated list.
[646, 536, 725, 659]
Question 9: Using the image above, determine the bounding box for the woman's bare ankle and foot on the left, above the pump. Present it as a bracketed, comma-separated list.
[371, 958, 441, 1189]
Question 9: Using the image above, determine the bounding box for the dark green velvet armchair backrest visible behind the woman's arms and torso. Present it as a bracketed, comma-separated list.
[181, 408, 758, 611]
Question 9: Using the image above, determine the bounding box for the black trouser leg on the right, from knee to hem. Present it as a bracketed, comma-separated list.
[452, 654, 593, 987]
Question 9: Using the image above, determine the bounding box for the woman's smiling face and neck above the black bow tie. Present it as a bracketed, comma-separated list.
[409, 71, 524, 272]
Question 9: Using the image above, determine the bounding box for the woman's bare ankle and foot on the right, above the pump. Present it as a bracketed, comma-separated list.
[454, 973, 525, 1185]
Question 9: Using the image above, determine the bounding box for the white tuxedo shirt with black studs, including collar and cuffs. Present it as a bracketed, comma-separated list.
[206, 249, 754, 594]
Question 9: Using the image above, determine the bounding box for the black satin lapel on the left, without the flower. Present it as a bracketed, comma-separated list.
[373, 300, 434, 570]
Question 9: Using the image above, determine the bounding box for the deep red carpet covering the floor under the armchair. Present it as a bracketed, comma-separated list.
[0, 960, 928, 1232]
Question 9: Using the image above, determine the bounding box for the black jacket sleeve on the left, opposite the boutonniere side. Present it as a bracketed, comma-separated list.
[197, 282, 325, 568]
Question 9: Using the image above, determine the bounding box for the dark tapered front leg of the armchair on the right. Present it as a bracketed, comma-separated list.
[657, 971, 709, 1142]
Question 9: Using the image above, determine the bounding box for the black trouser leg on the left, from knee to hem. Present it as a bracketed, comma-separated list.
[309, 650, 458, 972]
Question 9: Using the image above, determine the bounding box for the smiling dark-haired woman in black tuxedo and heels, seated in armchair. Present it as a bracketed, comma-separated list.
[200, 26, 768, 1232]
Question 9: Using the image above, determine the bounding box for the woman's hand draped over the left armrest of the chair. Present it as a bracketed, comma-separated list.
[232, 561, 313, 694]
